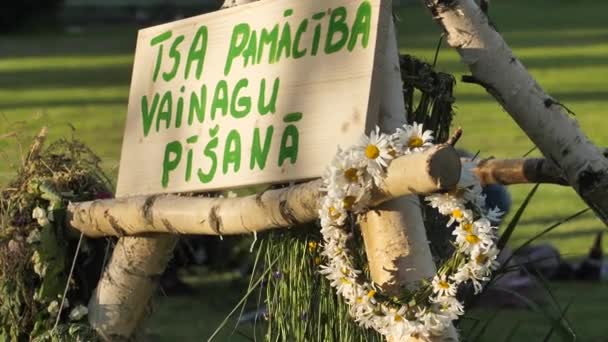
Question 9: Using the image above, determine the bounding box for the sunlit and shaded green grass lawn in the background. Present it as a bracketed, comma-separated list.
[0, 0, 608, 341]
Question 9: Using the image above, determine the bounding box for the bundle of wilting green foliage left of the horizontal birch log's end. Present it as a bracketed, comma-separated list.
[0, 136, 110, 341]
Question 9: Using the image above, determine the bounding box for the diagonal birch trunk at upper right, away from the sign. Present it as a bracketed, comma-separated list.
[425, 0, 608, 225]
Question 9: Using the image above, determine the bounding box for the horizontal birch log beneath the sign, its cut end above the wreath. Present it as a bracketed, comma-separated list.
[67, 145, 461, 237]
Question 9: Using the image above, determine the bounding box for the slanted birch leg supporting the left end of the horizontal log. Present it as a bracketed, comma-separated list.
[89, 0, 262, 341]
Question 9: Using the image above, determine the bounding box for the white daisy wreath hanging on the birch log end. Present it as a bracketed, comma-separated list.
[320, 123, 502, 341]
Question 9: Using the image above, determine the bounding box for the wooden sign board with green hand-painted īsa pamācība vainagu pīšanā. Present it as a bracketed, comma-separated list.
[117, 0, 392, 197]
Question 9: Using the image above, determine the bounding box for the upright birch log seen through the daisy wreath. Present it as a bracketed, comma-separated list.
[359, 12, 460, 342]
